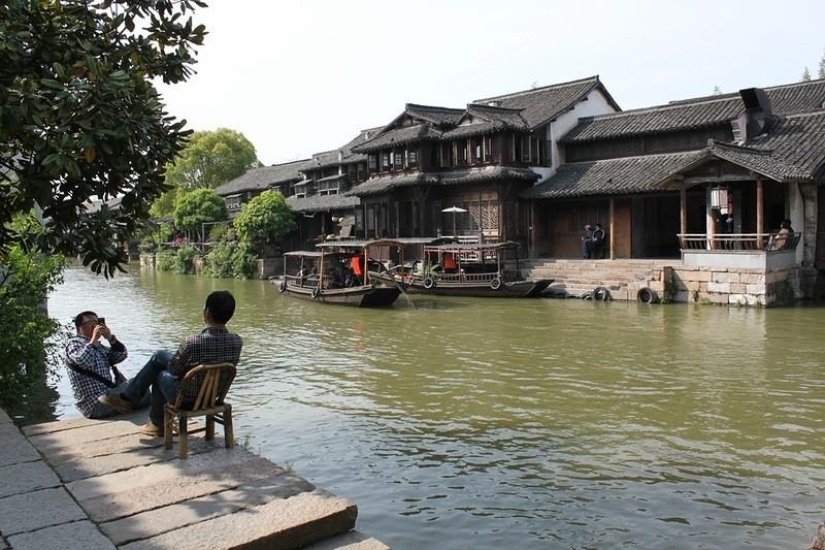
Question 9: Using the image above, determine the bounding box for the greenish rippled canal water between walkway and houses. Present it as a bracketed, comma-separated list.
[43, 268, 825, 550]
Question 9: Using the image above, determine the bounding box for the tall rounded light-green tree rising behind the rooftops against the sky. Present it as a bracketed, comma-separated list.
[166, 128, 258, 189]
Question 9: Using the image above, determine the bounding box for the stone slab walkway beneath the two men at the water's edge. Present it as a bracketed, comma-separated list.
[0, 410, 388, 550]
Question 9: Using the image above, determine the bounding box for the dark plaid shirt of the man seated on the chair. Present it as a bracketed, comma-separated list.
[168, 327, 243, 401]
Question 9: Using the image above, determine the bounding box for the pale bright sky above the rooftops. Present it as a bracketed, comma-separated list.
[159, 0, 825, 165]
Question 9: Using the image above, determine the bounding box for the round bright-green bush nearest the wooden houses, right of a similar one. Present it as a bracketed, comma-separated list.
[234, 189, 297, 248]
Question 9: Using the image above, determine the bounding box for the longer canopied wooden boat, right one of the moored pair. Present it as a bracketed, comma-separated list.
[370, 241, 553, 298]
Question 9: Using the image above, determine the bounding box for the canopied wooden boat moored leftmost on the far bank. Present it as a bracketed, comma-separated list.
[278, 247, 402, 307]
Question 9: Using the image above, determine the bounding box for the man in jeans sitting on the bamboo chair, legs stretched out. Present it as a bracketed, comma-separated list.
[98, 290, 243, 437]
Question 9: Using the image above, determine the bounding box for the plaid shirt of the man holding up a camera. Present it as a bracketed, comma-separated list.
[66, 335, 128, 416]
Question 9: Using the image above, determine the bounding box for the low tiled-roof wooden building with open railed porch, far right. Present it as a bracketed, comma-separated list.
[521, 80, 825, 265]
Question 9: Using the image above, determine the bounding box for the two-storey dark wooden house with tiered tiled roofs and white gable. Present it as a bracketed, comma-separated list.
[347, 77, 619, 250]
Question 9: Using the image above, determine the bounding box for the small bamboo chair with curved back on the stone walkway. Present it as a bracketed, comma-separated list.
[163, 363, 235, 458]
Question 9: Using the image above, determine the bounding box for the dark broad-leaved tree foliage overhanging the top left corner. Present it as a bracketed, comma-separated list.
[0, 0, 206, 275]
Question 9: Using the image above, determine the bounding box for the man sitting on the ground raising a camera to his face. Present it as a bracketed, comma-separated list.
[66, 311, 148, 418]
